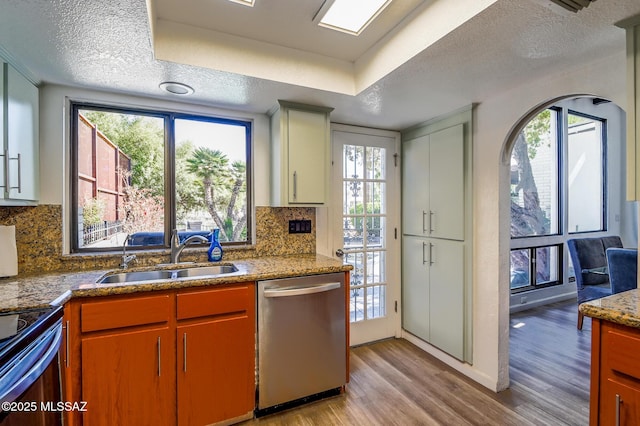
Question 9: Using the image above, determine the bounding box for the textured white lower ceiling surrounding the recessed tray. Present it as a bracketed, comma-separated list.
[0, 0, 640, 129]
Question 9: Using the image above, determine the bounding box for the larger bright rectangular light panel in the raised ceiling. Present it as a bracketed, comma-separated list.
[314, 0, 391, 35]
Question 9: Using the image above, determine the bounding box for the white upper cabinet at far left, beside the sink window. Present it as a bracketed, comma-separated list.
[0, 63, 40, 205]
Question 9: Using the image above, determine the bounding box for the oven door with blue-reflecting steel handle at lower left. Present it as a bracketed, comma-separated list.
[0, 320, 62, 426]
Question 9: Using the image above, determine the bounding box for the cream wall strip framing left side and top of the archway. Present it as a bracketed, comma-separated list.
[473, 50, 627, 390]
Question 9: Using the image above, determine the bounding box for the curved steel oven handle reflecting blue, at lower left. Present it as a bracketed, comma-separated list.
[0, 321, 62, 402]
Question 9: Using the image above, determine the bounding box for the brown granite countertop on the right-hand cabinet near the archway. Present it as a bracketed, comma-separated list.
[579, 289, 640, 328]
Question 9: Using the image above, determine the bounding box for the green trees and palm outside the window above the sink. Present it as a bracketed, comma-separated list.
[82, 111, 247, 241]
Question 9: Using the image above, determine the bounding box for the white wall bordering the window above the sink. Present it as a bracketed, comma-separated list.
[40, 84, 270, 253]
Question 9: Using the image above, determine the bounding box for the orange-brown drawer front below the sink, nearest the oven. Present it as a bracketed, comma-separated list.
[80, 295, 171, 333]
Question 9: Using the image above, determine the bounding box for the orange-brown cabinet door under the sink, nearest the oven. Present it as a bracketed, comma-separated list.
[82, 326, 176, 426]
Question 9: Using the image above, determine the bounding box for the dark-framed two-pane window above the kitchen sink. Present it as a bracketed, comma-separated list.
[71, 104, 252, 251]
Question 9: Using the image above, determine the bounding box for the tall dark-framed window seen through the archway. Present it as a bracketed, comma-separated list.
[510, 107, 606, 293]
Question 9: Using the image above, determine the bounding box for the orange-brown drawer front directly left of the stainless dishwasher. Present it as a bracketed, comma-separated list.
[176, 283, 255, 320]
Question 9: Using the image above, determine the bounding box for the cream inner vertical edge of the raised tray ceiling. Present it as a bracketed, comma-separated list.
[147, 0, 497, 96]
